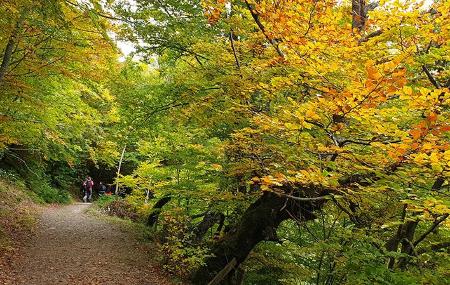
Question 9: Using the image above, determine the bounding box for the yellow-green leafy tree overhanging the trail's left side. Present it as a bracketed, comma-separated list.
[0, 0, 118, 195]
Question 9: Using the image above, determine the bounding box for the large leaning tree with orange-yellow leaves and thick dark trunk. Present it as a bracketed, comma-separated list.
[110, 1, 450, 283]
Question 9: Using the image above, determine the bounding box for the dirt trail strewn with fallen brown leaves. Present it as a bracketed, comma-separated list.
[5, 204, 171, 285]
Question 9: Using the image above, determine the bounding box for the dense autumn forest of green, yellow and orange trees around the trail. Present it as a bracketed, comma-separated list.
[0, 0, 450, 285]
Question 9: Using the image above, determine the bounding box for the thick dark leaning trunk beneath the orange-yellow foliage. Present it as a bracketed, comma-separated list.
[192, 192, 324, 284]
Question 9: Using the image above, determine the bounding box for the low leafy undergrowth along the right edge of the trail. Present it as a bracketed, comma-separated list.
[94, 195, 213, 280]
